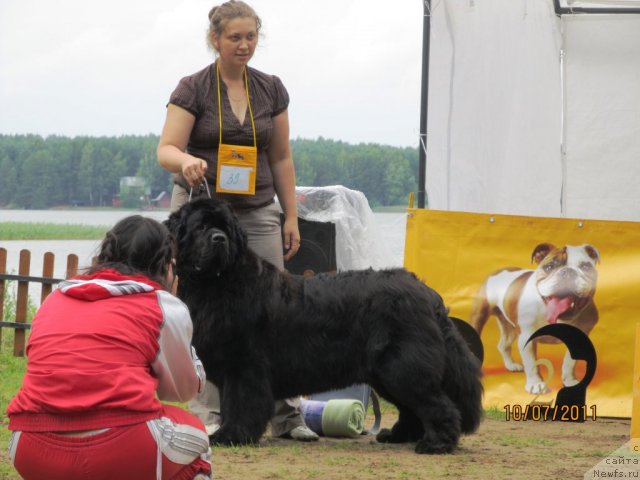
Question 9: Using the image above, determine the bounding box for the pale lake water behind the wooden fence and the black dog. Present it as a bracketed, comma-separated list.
[0, 210, 406, 304]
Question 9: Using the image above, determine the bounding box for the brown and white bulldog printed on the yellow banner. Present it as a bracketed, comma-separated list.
[470, 243, 600, 394]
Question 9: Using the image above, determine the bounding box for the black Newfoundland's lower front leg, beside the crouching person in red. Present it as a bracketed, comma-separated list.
[209, 368, 274, 445]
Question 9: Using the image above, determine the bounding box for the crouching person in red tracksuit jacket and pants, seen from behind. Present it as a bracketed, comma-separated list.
[7, 215, 211, 480]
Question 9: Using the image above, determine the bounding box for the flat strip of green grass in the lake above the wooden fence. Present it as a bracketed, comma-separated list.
[0, 222, 109, 240]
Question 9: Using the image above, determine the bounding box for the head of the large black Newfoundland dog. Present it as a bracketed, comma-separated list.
[165, 199, 247, 279]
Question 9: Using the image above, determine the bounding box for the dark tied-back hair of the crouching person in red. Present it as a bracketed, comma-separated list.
[87, 215, 176, 289]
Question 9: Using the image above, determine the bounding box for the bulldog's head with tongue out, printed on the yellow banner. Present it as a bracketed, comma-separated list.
[531, 243, 600, 323]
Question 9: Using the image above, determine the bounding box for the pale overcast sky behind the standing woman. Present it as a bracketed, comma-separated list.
[0, 0, 423, 147]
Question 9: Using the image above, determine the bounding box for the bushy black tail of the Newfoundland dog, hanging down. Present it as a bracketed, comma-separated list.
[437, 305, 483, 433]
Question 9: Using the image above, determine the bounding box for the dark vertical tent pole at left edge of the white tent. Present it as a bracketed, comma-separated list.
[418, 0, 431, 208]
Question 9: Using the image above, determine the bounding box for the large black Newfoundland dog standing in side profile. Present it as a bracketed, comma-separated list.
[166, 199, 482, 453]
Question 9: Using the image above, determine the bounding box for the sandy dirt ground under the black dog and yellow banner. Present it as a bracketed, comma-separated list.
[212, 414, 640, 480]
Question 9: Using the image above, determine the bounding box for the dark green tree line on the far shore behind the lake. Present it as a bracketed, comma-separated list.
[0, 135, 418, 209]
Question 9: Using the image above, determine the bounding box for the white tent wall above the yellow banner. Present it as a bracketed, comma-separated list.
[425, 0, 640, 221]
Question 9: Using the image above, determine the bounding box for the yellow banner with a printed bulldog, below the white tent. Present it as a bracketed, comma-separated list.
[405, 208, 640, 420]
